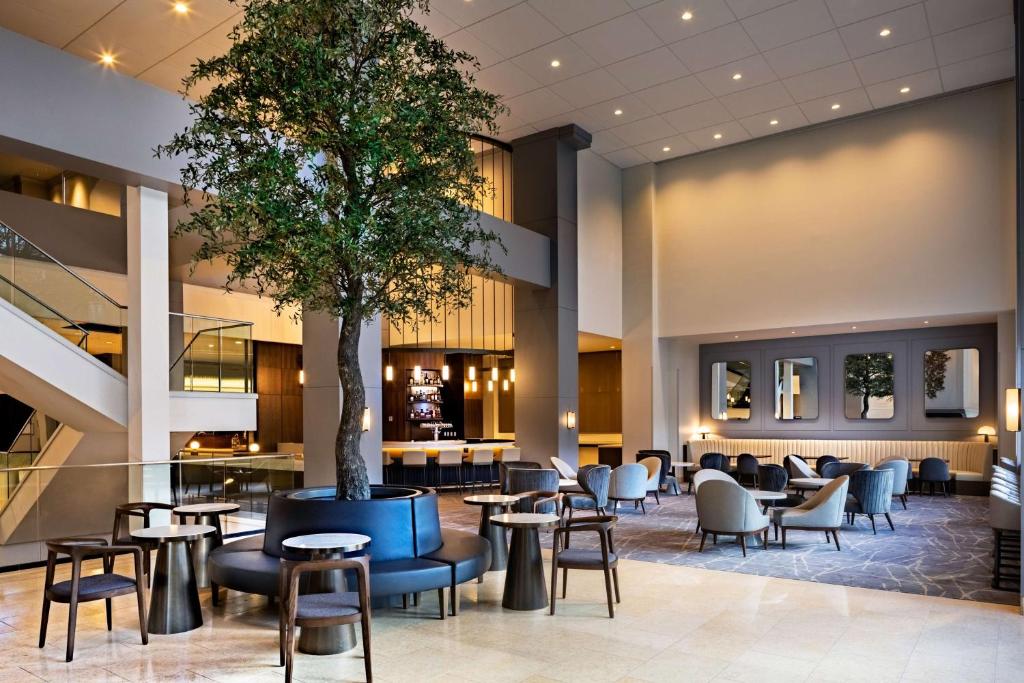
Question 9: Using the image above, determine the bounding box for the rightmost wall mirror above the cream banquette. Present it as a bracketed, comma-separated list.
[925, 348, 981, 418]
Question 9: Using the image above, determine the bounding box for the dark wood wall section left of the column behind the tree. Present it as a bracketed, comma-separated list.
[254, 341, 302, 452]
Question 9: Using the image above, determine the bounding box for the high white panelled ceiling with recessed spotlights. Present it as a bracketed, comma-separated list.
[0, 0, 1013, 168]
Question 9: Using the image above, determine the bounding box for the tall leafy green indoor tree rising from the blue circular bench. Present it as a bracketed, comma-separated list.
[157, 0, 502, 499]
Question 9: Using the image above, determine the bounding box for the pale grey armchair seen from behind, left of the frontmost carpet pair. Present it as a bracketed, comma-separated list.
[696, 479, 768, 557]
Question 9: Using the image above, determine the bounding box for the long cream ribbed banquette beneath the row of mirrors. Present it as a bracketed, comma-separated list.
[689, 438, 992, 481]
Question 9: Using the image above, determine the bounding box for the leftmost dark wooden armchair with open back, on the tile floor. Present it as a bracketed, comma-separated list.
[39, 539, 150, 661]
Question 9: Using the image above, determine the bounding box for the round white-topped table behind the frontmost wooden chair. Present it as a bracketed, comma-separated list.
[281, 532, 370, 654]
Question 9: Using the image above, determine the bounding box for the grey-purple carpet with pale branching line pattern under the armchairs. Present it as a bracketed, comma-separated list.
[440, 493, 1018, 604]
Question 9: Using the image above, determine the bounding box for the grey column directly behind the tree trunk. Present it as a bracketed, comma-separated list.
[302, 312, 383, 486]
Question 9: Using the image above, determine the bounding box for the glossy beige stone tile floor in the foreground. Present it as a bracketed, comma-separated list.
[0, 548, 1024, 683]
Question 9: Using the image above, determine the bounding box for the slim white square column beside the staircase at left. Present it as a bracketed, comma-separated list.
[127, 187, 171, 502]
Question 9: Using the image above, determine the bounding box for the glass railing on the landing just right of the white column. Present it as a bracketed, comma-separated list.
[170, 313, 253, 393]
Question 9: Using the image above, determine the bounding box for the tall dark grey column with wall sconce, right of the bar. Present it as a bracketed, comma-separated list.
[512, 126, 590, 466]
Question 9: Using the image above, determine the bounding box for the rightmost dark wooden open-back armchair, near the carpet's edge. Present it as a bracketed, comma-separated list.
[550, 515, 622, 618]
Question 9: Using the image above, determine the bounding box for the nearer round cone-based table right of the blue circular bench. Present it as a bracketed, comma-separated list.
[490, 512, 559, 610]
